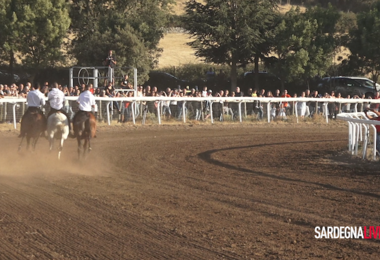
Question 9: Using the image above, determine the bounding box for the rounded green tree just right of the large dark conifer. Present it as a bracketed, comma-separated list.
[266, 6, 340, 89]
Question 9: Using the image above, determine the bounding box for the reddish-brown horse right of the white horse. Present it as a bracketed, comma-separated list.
[73, 111, 96, 159]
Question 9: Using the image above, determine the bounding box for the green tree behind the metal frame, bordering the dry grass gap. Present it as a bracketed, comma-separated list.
[71, 0, 173, 82]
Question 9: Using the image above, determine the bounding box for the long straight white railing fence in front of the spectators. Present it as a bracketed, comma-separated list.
[0, 97, 380, 129]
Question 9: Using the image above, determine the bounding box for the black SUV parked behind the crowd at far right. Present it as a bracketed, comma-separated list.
[318, 76, 380, 98]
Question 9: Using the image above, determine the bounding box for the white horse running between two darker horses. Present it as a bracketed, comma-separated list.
[47, 111, 69, 160]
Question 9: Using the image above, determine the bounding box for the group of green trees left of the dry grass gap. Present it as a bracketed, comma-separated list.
[0, 0, 174, 81]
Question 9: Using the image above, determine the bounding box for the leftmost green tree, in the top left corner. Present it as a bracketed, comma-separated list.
[2, 0, 70, 79]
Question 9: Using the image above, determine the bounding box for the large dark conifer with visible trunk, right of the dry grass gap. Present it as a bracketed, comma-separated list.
[184, 0, 277, 90]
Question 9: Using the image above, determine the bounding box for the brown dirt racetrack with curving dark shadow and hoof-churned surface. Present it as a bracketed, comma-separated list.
[0, 125, 380, 260]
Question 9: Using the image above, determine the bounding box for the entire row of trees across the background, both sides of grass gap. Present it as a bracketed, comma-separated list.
[0, 0, 380, 88]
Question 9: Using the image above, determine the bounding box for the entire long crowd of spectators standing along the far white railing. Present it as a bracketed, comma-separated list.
[0, 80, 380, 121]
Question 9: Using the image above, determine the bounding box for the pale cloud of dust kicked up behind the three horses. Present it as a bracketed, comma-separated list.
[0, 138, 111, 177]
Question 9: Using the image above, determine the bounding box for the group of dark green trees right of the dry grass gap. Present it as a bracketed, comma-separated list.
[184, 0, 380, 88]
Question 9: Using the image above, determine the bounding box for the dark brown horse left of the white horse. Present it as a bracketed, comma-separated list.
[18, 108, 46, 151]
